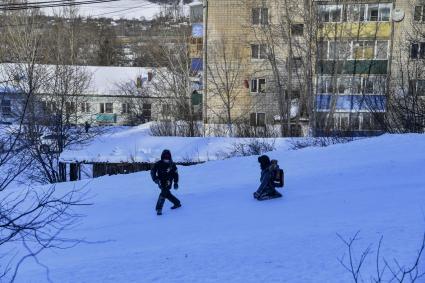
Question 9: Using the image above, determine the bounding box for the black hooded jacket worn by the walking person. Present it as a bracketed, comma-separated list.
[151, 150, 179, 189]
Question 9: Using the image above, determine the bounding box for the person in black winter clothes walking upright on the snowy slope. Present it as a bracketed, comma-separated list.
[151, 149, 181, 215]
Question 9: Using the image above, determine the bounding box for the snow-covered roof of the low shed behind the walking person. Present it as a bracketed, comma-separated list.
[60, 123, 288, 163]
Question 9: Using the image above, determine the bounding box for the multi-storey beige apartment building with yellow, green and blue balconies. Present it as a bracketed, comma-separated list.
[204, 0, 425, 135]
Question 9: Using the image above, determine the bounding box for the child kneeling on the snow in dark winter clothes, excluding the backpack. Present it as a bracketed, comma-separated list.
[254, 155, 282, 200]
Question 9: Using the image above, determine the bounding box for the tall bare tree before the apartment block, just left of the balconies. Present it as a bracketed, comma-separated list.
[242, 0, 315, 136]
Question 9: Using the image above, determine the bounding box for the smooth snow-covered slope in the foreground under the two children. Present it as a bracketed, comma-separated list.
[17, 135, 425, 283]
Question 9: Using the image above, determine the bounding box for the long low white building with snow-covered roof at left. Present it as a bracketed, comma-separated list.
[0, 64, 178, 125]
